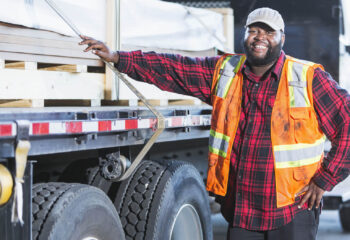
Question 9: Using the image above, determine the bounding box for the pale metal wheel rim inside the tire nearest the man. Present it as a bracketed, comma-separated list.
[170, 204, 203, 240]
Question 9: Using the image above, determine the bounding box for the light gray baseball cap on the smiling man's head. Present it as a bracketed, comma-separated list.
[245, 7, 284, 32]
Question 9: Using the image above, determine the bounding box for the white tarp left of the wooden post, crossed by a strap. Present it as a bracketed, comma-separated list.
[0, 0, 106, 40]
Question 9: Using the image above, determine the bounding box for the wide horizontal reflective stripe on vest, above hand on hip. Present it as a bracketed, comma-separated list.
[273, 137, 325, 168]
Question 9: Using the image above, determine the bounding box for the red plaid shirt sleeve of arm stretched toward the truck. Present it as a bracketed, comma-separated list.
[116, 51, 219, 104]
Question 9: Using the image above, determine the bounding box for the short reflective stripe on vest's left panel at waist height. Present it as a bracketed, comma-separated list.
[209, 129, 230, 158]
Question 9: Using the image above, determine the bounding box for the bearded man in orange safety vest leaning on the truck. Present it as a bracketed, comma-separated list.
[80, 8, 350, 240]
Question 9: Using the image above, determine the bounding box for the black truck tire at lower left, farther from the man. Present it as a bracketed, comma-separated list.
[32, 183, 125, 240]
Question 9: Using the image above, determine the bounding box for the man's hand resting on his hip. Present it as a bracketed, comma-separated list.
[296, 180, 325, 210]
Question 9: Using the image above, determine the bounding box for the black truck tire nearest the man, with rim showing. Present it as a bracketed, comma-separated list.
[114, 161, 213, 240]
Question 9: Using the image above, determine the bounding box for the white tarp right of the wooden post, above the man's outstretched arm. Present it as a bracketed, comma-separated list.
[121, 0, 225, 51]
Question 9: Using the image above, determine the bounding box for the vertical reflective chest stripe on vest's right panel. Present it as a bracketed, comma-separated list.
[287, 61, 310, 108]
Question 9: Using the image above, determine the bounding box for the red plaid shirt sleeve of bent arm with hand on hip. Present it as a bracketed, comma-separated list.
[312, 68, 350, 191]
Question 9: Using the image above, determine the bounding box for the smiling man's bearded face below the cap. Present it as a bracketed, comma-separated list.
[244, 23, 284, 66]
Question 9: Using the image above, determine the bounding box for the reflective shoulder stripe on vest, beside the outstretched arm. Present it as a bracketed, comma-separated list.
[215, 55, 244, 98]
